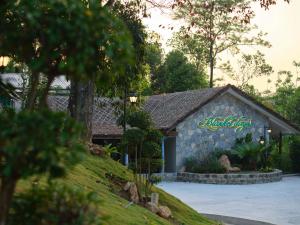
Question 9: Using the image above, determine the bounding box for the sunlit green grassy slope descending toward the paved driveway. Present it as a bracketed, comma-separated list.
[18, 156, 217, 225]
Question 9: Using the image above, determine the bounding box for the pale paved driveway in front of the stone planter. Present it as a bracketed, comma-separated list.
[158, 177, 300, 225]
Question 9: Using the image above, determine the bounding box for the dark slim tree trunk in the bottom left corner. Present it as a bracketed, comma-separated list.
[0, 179, 17, 225]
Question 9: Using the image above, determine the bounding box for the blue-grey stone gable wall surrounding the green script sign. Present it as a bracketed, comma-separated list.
[176, 93, 269, 171]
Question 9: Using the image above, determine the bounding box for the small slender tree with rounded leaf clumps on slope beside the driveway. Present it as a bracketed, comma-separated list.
[119, 110, 162, 197]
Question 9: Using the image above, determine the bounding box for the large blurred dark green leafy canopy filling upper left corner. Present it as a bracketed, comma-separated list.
[0, 0, 132, 78]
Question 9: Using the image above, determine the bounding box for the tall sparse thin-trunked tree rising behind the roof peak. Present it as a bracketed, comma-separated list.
[175, 0, 268, 87]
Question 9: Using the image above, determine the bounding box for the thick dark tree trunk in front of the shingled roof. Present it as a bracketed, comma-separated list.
[69, 80, 94, 142]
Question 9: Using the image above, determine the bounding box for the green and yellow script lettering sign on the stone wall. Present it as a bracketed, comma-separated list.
[198, 116, 253, 131]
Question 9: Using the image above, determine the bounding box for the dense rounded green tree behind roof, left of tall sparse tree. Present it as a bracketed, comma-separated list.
[153, 51, 207, 93]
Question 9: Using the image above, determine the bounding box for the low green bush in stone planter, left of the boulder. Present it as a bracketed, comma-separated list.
[184, 154, 226, 173]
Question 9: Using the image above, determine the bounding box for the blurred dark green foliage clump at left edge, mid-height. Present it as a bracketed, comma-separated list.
[0, 110, 84, 178]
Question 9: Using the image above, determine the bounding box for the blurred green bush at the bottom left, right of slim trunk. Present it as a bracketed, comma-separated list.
[8, 184, 102, 225]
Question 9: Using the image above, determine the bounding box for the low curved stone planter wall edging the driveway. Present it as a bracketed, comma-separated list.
[176, 169, 282, 184]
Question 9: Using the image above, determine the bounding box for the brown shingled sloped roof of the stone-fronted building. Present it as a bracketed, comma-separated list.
[48, 85, 299, 137]
